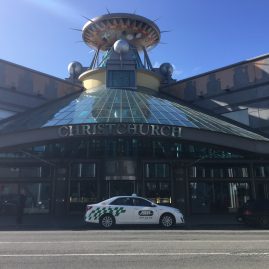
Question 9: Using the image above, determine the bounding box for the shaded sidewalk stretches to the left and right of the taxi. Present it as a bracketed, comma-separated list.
[0, 215, 245, 230]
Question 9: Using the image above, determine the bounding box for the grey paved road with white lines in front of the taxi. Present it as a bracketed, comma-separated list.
[0, 229, 269, 269]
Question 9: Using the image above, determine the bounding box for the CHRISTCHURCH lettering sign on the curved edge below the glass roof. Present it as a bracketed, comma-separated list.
[58, 123, 181, 138]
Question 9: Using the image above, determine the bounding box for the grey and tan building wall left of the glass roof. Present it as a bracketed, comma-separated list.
[0, 59, 81, 120]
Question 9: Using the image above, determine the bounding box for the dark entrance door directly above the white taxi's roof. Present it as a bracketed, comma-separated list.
[107, 180, 135, 197]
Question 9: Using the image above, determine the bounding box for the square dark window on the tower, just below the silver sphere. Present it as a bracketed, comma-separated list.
[107, 70, 135, 88]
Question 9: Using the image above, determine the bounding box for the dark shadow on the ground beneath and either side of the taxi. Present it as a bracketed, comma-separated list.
[0, 215, 255, 231]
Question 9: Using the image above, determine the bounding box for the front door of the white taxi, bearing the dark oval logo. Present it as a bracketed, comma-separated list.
[133, 198, 159, 224]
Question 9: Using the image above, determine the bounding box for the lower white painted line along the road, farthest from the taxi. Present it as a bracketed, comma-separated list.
[0, 252, 269, 258]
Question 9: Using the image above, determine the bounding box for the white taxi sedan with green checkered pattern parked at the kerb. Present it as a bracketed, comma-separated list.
[85, 195, 184, 229]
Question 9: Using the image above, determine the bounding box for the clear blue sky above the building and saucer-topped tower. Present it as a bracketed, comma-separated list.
[0, 0, 269, 79]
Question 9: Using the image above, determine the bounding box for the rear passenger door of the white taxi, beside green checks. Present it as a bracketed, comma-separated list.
[109, 197, 134, 224]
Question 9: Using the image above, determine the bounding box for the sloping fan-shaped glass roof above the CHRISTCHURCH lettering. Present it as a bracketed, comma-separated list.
[0, 87, 269, 141]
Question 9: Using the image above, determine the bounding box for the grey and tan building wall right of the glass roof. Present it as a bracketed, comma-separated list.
[162, 54, 269, 134]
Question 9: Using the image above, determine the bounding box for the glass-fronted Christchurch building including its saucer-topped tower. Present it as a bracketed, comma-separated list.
[0, 13, 269, 216]
